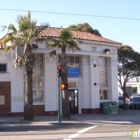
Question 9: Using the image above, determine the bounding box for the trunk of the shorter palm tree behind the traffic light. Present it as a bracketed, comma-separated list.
[60, 47, 70, 120]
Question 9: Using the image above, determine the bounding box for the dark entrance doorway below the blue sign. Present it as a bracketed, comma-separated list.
[69, 89, 78, 114]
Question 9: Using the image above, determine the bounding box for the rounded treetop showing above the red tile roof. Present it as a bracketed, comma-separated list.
[68, 23, 102, 36]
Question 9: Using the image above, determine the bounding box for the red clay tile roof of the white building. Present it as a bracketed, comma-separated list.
[41, 27, 122, 45]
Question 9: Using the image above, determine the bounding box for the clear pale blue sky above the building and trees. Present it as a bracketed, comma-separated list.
[0, 0, 140, 52]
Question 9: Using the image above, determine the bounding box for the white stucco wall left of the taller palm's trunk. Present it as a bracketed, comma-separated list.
[0, 50, 24, 112]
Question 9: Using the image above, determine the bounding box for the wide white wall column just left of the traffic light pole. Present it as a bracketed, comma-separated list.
[44, 54, 58, 115]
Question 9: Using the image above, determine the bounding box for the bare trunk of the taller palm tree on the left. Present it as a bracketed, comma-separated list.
[24, 44, 34, 120]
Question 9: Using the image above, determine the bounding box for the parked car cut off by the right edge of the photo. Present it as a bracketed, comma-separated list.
[128, 96, 140, 109]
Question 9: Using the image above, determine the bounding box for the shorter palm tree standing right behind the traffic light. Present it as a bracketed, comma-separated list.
[47, 29, 81, 119]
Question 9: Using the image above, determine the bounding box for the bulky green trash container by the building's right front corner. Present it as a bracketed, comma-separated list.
[102, 102, 119, 114]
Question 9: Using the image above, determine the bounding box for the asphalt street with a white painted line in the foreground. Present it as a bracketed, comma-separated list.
[0, 123, 140, 140]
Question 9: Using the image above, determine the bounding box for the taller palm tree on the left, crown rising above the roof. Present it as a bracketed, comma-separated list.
[2, 12, 49, 120]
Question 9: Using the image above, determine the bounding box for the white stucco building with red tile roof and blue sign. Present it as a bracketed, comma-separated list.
[0, 28, 121, 116]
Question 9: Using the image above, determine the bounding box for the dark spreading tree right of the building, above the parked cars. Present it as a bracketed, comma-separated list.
[118, 45, 140, 109]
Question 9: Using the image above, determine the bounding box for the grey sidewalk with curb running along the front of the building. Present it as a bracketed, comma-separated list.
[0, 109, 140, 125]
